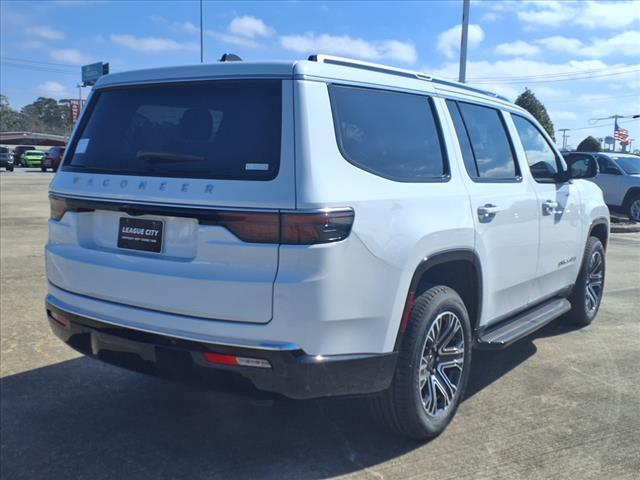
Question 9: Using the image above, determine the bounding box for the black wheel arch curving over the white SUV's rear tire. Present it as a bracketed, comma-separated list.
[394, 249, 482, 351]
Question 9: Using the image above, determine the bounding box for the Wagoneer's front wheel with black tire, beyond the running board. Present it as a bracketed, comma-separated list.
[567, 237, 606, 327]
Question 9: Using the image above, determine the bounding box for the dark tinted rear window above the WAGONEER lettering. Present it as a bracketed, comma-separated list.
[63, 80, 282, 180]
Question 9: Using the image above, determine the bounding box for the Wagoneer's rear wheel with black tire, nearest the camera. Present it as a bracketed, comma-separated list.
[370, 286, 471, 440]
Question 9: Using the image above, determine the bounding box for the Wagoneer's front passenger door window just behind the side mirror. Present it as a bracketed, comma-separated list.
[511, 115, 560, 182]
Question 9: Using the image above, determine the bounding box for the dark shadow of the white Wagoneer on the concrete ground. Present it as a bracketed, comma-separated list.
[0, 340, 536, 480]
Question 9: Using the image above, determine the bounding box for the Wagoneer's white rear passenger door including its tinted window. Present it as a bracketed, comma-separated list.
[447, 100, 538, 324]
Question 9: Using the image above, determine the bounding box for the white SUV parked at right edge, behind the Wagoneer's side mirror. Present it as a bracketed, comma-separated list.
[565, 152, 640, 222]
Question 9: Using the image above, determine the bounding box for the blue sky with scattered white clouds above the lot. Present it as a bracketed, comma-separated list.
[0, 0, 640, 149]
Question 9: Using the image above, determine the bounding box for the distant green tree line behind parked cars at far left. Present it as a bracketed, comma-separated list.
[0, 95, 71, 135]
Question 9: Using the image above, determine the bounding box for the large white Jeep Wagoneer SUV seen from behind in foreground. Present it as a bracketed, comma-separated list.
[46, 55, 609, 438]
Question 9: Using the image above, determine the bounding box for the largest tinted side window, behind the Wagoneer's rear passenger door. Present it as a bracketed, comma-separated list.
[329, 85, 449, 182]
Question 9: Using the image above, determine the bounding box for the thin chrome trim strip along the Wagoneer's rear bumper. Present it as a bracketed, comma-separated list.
[45, 287, 302, 351]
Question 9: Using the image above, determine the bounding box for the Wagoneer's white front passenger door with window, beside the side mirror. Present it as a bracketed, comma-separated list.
[511, 114, 584, 299]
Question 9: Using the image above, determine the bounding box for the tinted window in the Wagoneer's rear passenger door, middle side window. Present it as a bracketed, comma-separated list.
[458, 102, 520, 180]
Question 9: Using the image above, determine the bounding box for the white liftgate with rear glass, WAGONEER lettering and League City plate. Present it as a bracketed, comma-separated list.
[47, 79, 295, 323]
